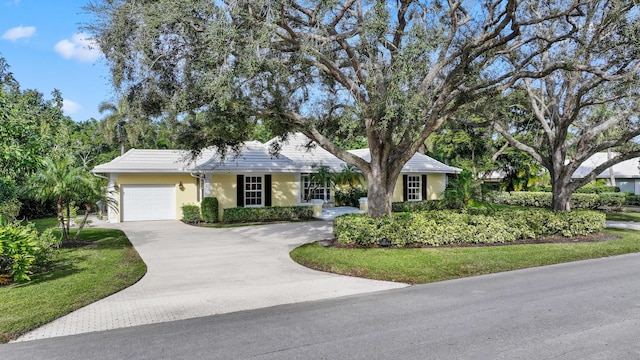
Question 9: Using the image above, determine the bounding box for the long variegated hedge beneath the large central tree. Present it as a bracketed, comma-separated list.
[334, 209, 605, 246]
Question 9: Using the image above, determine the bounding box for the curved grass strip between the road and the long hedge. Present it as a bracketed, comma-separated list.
[291, 230, 640, 284]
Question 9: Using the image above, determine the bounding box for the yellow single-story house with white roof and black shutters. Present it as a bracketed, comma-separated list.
[92, 133, 461, 222]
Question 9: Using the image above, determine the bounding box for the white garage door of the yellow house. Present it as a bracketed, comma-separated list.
[121, 185, 176, 221]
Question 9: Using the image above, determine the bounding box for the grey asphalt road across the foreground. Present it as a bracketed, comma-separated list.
[0, 254, 640, 360]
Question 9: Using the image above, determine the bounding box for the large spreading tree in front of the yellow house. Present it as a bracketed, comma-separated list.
[87, 0, 581, 217]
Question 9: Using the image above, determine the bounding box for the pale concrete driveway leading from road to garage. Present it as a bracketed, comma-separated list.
[18, 221, 406, 341]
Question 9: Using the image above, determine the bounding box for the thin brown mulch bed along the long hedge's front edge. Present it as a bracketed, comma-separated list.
[318, 233, 620, 249]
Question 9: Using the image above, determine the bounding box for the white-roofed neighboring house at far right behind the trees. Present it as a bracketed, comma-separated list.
[573, 153, 640, 194]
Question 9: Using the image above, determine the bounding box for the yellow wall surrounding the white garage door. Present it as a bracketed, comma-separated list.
[115, 174, 200, 221]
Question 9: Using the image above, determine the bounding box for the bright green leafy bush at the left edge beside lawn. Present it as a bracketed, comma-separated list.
[0, 223, 57, 282]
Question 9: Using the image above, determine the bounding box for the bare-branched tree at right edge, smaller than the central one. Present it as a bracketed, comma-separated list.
[494, 0, 640, 210]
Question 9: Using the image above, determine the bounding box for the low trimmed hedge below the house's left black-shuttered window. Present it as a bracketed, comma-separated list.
[222, 206, 313, 222]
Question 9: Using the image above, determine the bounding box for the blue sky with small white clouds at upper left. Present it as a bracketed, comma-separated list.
[0, 0, 115, 121]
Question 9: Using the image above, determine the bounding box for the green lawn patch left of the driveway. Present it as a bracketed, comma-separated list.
[0, 225, 146, 343]
